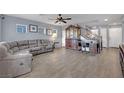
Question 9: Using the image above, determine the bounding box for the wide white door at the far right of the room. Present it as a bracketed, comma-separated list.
[109, 27, 122, 47]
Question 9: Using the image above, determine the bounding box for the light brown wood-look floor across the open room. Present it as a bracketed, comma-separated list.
[19, 48, 122, 78]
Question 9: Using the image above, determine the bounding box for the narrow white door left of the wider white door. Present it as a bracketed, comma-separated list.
[100, 28, 107, 47]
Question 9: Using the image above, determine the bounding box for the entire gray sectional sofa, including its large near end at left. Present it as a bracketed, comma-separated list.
[0, 39, 54, 77]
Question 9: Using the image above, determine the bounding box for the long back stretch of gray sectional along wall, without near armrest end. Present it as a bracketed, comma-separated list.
[2, 39, 54, 55]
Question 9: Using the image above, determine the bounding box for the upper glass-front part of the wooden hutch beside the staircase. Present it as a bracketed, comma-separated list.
[66, 25, 81, 39]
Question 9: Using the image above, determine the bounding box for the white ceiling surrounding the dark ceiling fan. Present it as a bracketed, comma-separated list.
[7, 14, 124, 26]
